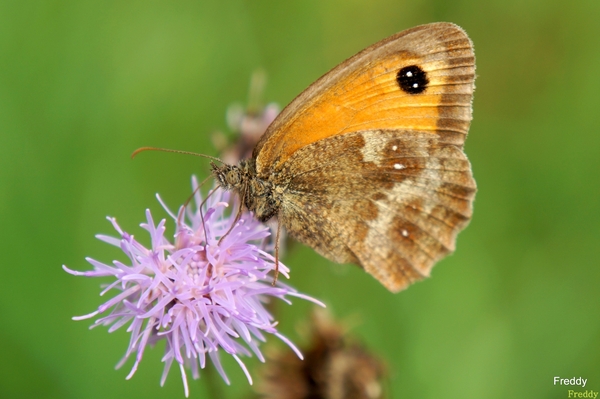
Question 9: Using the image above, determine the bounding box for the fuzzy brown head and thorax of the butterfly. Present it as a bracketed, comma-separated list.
[211, 159, 281, 222]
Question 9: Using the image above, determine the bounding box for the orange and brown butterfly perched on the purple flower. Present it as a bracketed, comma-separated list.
[212, 23, 476, 292]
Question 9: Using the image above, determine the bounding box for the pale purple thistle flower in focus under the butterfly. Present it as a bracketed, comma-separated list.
[63, 178, 324, 397]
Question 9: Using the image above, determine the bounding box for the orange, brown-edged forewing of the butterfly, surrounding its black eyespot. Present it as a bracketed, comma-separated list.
[254, 23, 475, 176]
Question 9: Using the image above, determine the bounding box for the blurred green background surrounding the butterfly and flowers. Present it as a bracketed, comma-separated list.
[0, 0, 600, 398]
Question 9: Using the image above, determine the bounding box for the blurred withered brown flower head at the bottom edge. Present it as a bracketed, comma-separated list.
[256, 309, 387, 399]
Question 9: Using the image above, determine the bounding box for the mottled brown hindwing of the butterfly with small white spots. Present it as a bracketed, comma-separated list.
[280, 130, 475, 291]
